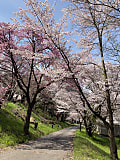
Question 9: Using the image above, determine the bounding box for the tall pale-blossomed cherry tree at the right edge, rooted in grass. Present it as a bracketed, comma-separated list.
[66, 0, 120, 159]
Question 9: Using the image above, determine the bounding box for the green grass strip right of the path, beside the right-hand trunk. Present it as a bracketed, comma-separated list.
[73, 130, 120, 160]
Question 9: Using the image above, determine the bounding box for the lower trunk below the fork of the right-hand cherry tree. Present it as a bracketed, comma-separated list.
[108, 126, 118, 160]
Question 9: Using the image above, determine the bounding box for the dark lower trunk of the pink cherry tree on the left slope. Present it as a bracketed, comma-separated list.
[24, 104, 33, 135]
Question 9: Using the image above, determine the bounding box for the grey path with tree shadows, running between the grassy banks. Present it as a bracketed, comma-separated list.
[0, 126, 77, 160]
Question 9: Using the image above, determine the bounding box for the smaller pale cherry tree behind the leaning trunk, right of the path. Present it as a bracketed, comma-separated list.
[58, 79, 96, 137]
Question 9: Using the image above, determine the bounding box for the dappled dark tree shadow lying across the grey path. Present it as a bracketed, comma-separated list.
[15, 126, 77, 151]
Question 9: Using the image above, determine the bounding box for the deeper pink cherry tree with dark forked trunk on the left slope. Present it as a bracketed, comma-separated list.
[0, 23, 62, 134]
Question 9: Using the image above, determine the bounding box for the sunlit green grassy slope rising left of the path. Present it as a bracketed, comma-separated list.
[0, 103, 70, 148]
